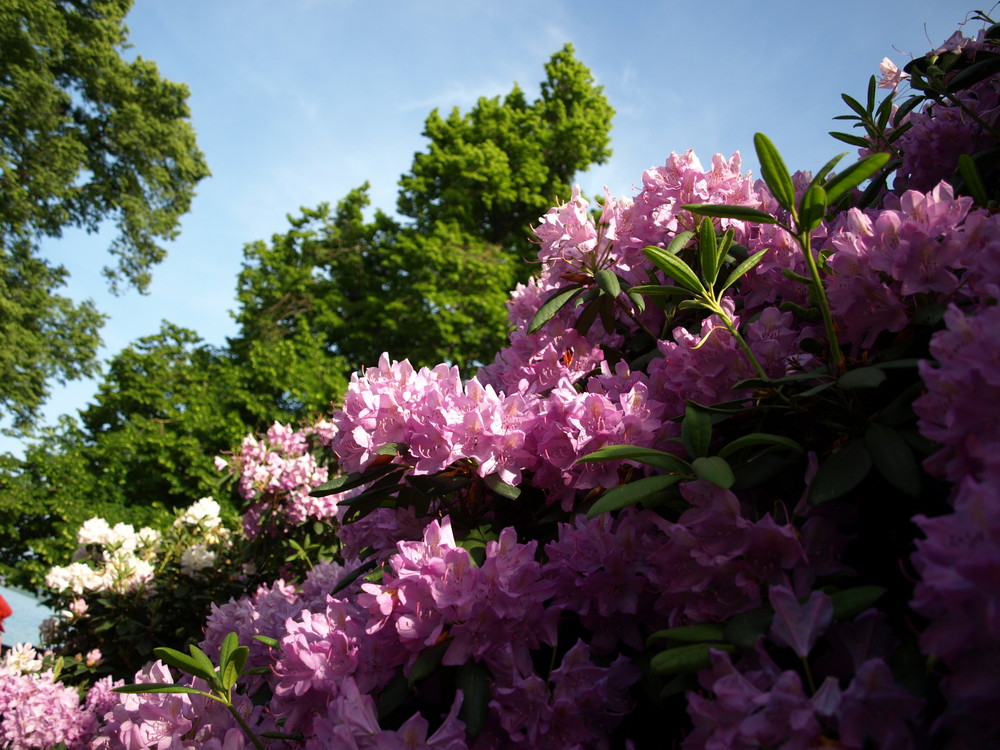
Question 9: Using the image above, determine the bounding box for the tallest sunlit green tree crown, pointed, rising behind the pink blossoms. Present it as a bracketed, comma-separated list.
[398, 44, 614, 268]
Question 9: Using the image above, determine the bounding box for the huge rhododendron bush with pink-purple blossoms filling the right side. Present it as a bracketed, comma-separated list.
[7, 16, 1000, 750]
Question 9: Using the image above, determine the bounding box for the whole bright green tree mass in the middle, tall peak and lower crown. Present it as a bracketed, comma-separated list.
[233, 45, 613, 374]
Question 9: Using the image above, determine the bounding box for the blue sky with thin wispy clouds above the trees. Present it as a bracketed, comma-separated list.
[0, 0, 978, 451]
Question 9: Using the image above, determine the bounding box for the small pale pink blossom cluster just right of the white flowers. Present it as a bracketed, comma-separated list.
[215, 422, 337, 539]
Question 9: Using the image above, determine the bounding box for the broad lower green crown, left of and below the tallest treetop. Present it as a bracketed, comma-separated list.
[232, 185, 515, 376]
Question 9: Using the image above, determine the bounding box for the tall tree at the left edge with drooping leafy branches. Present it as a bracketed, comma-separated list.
[0, 0, 208, 427]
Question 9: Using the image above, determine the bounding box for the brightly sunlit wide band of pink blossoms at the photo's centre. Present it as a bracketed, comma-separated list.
[331, 355, 659, 503]
